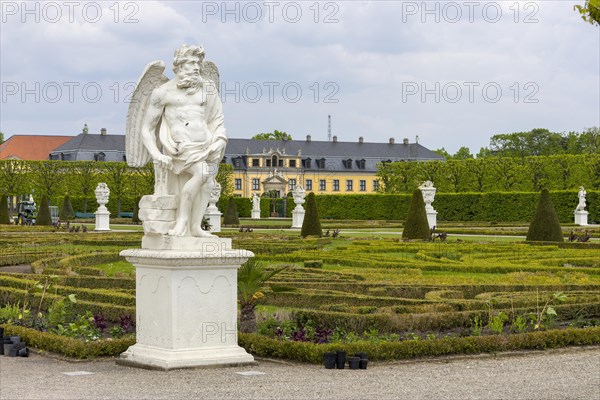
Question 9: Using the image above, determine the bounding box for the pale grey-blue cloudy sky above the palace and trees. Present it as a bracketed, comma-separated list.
[0, 0, 600, 153]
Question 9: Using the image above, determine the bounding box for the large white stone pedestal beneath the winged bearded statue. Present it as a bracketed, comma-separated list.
[117, 235, 254, 370]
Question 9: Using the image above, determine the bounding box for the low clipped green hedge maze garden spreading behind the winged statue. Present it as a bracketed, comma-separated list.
[0, 226, 600, 362]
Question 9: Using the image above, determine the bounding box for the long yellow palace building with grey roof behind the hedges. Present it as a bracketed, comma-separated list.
[223, 135, 444, 197]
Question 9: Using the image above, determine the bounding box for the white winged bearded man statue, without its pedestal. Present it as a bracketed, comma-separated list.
[126, 45, 227, 237]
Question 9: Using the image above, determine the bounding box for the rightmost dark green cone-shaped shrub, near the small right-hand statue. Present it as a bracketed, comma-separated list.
[527, 189, 564, 242]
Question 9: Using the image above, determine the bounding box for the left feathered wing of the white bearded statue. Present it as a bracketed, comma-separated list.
[125, 61, 169, 168]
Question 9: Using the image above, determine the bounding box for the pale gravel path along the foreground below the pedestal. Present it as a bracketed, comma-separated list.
[0, 346, 600, 400]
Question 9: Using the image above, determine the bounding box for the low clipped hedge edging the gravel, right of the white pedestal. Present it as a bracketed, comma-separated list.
[238, 327, 600, 364]
